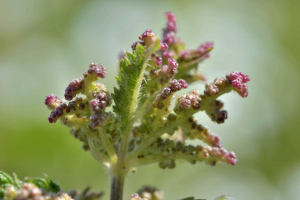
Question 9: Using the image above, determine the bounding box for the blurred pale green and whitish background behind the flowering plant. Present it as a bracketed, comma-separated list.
[0, 0, 300, 200]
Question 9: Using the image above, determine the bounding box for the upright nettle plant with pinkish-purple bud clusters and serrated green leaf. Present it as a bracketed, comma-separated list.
[1, 13, 250, 200]
